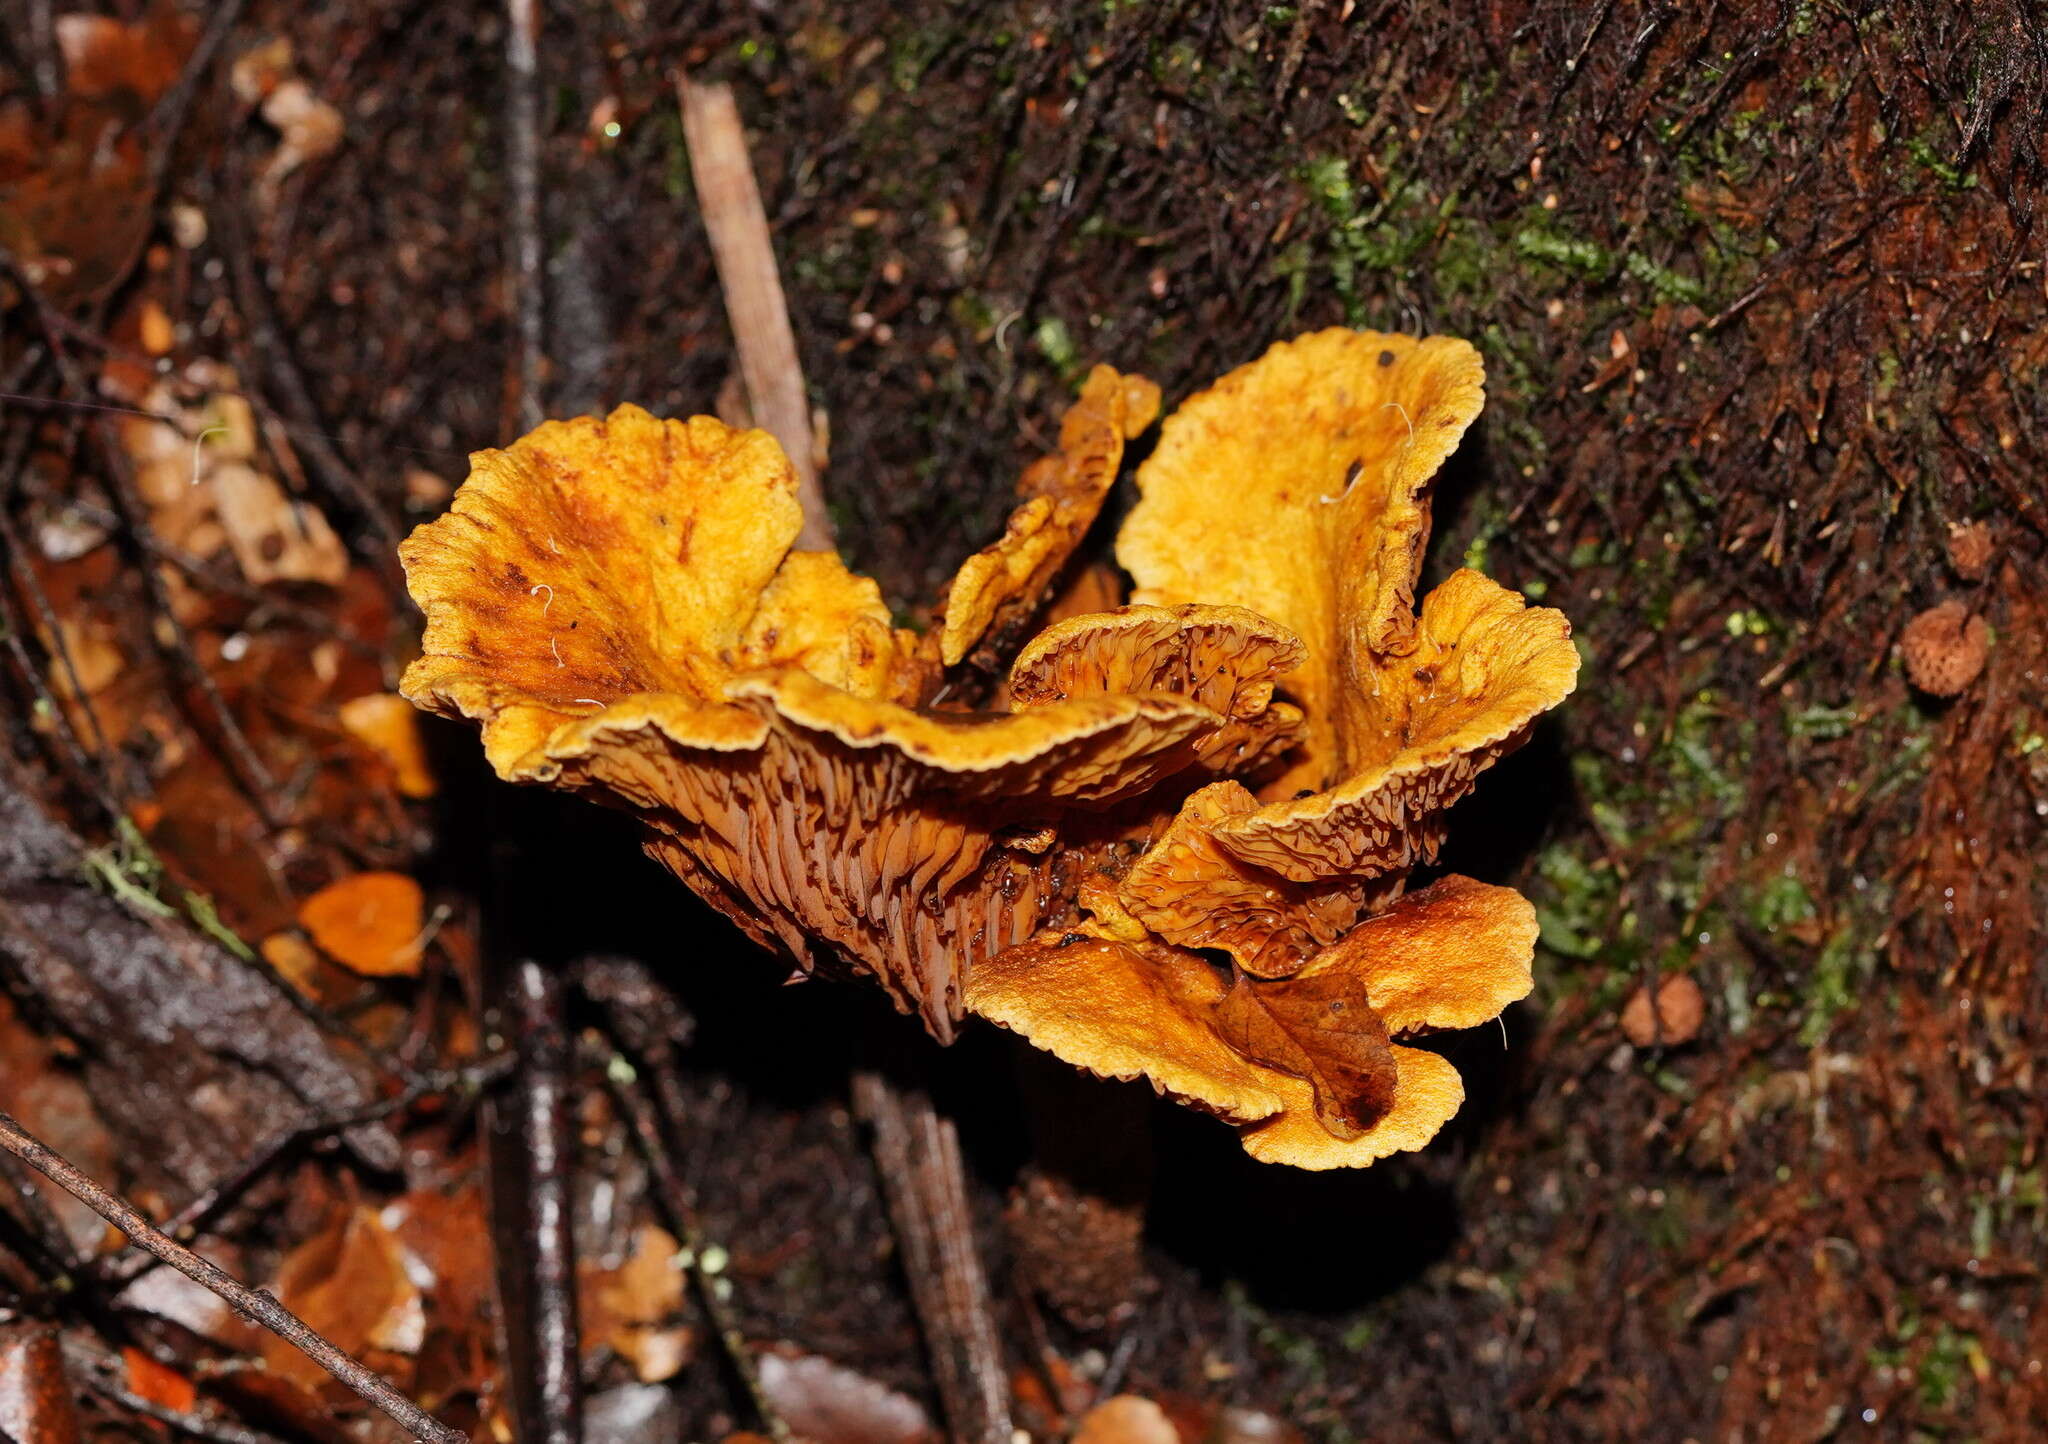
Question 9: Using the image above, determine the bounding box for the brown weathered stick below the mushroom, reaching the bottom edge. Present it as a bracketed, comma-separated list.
[854, 1069, 1012, 1444]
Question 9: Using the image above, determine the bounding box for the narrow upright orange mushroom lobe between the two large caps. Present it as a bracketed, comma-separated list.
[938, 367, 1159, 668]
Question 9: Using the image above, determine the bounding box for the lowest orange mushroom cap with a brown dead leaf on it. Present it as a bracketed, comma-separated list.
[967, 877, 1536, 1167]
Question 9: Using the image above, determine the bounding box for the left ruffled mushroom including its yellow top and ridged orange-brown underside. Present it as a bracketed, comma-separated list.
[401, 393, 1225, 1038]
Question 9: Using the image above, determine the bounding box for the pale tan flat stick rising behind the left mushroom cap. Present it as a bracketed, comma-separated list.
[676, 76, 831, 551]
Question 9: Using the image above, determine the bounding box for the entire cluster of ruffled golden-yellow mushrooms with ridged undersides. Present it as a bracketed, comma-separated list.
[401, 330, 1577, 1167]
